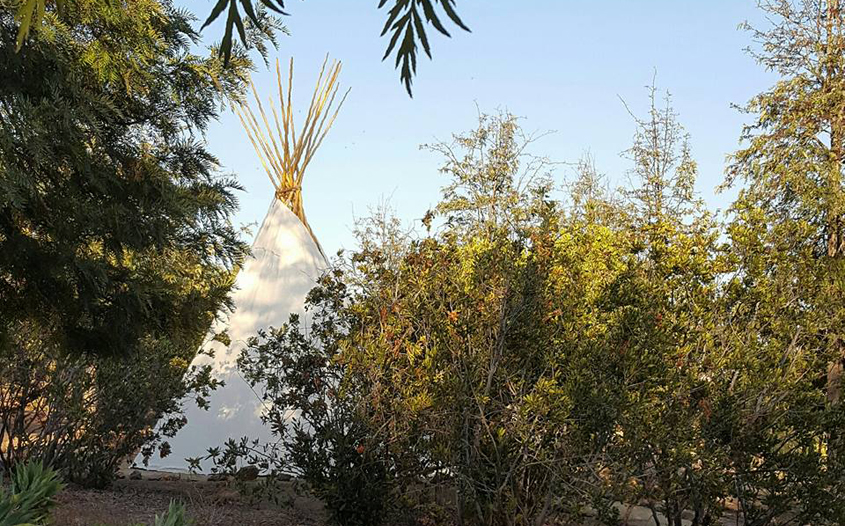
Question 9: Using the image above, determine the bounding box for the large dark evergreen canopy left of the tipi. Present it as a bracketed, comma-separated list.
[0, 0, 256, 354]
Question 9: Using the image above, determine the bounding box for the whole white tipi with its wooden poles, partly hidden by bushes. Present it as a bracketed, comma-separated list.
[136, 57, 348, 471]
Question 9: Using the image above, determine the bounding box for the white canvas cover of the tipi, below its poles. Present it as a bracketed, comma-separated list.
[149, 199, 326, 471]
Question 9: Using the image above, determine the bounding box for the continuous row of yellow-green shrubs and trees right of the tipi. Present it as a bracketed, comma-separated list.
[216, 1, 845, 526]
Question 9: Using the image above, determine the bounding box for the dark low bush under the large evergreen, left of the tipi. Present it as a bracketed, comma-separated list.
[0, 330, 223, 487]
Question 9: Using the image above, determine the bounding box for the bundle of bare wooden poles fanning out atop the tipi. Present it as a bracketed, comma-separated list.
[232, 55, 349, 257]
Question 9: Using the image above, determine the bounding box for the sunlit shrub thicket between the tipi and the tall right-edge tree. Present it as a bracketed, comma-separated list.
[227, 103, 843, 526]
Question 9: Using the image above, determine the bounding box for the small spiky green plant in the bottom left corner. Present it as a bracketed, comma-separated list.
[0, 462, 62, 526]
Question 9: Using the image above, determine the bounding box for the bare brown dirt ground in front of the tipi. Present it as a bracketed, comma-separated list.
[53, 476, 325, 526]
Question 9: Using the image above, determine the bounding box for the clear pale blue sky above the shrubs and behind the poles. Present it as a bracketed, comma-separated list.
[183, 0, 773, 253]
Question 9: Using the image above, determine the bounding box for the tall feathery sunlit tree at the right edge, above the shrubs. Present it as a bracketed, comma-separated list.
[727, 0, 845, 400]
